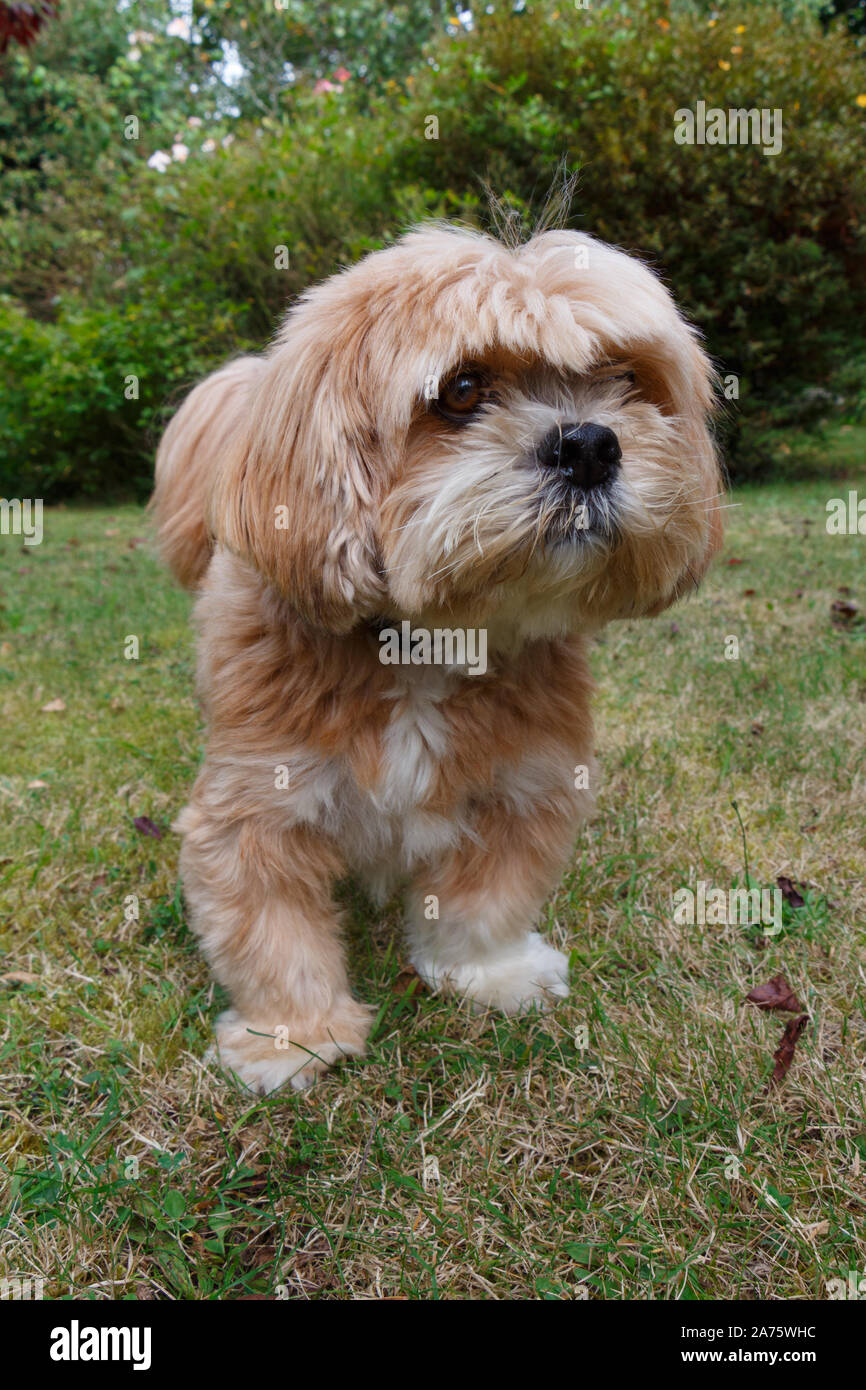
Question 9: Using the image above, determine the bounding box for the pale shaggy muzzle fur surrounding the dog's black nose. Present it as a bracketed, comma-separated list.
[384, 370, 706, 619]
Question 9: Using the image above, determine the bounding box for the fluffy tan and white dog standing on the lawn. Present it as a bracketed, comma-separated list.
[153, 224, 723, 1093]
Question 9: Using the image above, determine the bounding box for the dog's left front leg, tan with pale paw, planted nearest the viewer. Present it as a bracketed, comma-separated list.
[177, 796, 370, 1093]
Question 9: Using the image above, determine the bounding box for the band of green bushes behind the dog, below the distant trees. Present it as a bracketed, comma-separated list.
[0, 0, 866, 496]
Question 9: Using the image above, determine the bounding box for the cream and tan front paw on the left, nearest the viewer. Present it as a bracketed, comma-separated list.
[215, 999, 370, 1095]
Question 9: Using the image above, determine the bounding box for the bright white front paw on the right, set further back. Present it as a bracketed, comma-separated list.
[411, 931, 569, 1013]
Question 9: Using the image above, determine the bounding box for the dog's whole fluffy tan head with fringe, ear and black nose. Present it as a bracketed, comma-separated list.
[211, 227, 721, 634]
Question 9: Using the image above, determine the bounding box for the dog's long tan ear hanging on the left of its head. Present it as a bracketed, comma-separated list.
[210, 301, 385, 632]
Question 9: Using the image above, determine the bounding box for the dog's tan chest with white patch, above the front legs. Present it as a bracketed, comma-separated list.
[276, 639, 589, 881]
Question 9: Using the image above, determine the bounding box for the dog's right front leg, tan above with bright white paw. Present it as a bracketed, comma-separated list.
[407, 801, 577, 1013]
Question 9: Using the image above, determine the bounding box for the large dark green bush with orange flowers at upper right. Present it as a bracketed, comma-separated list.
[405, 4, 866, 471]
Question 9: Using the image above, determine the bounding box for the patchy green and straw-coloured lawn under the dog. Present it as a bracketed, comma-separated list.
[0, 458, 866, 1300]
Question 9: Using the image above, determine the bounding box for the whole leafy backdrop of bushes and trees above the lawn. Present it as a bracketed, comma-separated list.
[0, 0, 866, 500]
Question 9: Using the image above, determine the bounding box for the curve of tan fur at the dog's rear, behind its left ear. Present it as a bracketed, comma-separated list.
[150, 357, 261, 589]
